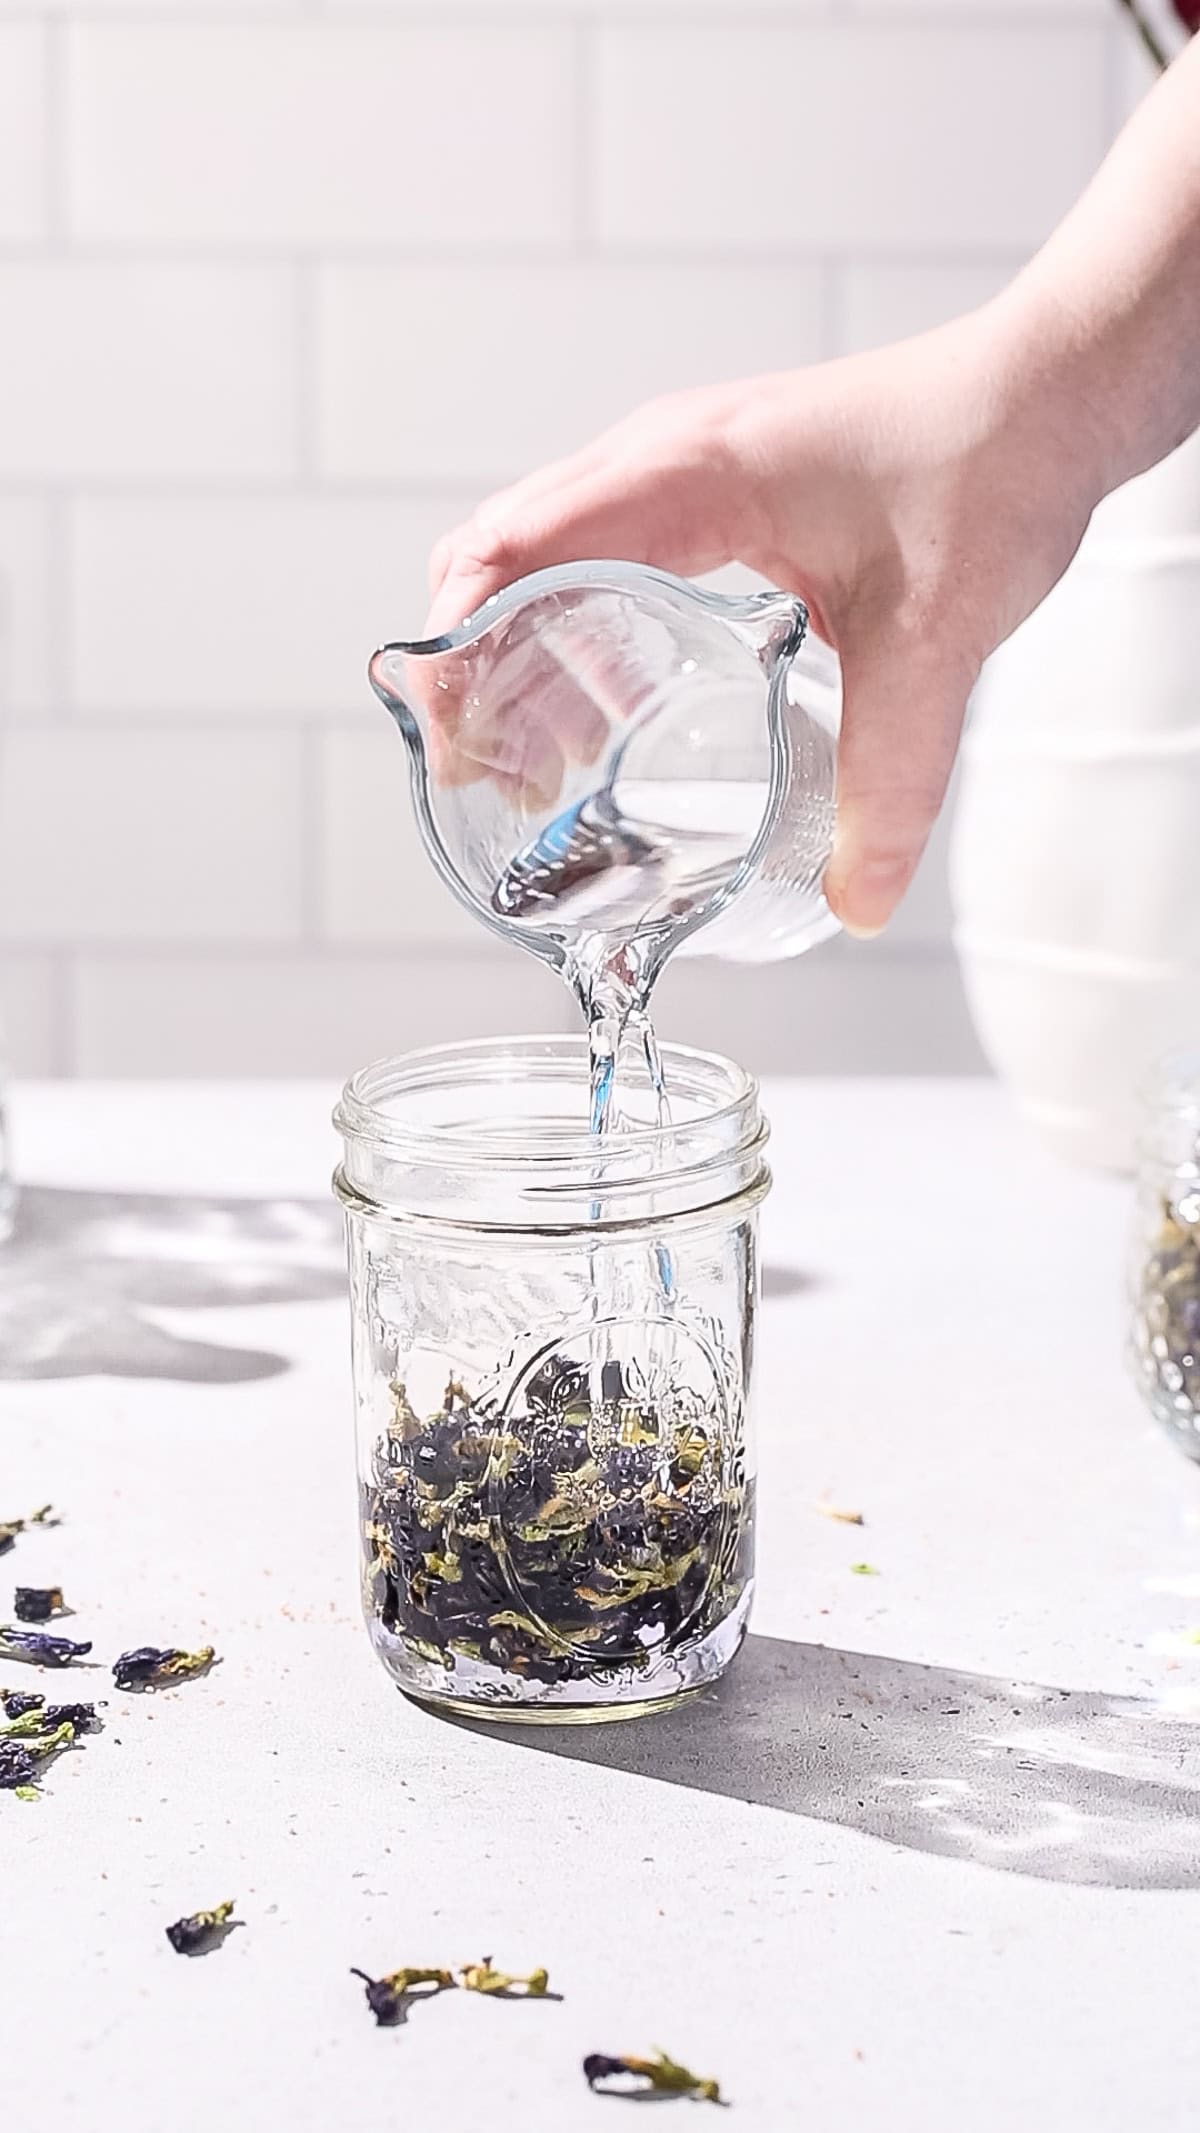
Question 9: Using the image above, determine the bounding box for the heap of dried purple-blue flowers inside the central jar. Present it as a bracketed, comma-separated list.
[362, 1357, 752, 1683]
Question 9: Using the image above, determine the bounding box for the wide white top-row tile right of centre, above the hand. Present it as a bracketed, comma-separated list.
[595, 19, 1106, 254]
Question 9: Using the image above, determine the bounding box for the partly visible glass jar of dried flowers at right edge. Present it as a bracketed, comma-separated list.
[1132, 1058, 1200, 1459]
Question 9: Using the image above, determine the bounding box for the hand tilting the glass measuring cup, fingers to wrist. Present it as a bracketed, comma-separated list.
[428, 299, 1102, 934]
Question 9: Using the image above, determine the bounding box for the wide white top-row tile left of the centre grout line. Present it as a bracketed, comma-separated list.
[66, 21, 573, 250]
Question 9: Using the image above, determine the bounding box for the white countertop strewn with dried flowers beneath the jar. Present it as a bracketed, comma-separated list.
[0, 1081, 1200, 2133]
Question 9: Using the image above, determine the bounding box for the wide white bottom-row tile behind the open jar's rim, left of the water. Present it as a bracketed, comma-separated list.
[73, 955, 571, 1079]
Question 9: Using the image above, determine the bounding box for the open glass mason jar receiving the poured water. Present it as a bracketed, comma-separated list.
[335, 1037, 769, 1721]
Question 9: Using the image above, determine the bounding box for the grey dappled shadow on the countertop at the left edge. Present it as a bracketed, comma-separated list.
[0, 1186, 345, 1384]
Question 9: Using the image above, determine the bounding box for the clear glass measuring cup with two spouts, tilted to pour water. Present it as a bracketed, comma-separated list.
[369, 563, 840, 976]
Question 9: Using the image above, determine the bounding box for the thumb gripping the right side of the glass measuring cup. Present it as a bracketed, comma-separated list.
[825, 642, 978, 936]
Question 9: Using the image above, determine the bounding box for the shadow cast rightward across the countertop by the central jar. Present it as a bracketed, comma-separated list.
[458, 1636, 1200, 1890]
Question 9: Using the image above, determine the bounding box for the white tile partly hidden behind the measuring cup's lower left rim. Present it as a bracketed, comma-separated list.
[318, 712, 488, 953]
